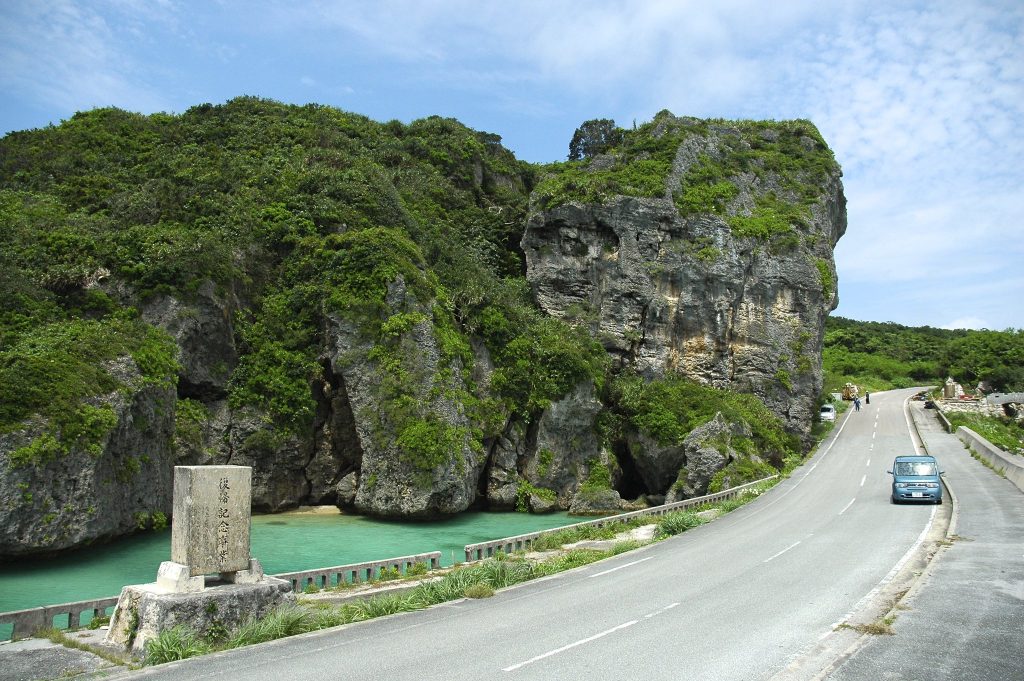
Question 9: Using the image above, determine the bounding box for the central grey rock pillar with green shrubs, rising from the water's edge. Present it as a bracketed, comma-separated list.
[328, 278, 483, 518]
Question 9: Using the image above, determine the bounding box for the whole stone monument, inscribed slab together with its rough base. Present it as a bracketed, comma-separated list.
[106, 466, 295, 654]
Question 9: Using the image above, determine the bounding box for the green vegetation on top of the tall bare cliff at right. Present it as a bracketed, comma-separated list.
[536, 112, 839, 246]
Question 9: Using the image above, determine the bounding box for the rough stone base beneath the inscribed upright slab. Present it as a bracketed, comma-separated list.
[106, 560, 295, 655]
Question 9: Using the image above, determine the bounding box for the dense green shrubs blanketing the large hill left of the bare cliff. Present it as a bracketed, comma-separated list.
[0, 97, 604, 463]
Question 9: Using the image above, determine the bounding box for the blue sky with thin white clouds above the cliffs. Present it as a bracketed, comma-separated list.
[0, 0, 1024, 330]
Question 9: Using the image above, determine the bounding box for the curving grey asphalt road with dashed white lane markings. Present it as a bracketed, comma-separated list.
[110, 391, 949, 681]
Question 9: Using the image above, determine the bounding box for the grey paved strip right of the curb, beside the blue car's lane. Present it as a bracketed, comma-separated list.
[826, 403, 1024, 681]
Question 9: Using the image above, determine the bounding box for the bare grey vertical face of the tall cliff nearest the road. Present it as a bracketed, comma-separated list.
[522, 115, 846, 437]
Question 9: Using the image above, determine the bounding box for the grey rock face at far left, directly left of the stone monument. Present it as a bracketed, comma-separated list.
[0, 358, 175, 557]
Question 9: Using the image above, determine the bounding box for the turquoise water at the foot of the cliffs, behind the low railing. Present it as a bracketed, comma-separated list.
[0, 512, 580, 614]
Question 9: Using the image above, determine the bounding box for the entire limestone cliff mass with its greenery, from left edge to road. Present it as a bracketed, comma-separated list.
[0, 98, 846, 558]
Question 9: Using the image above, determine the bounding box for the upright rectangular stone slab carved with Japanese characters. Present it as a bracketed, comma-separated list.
[171, 466, 252, 577]
